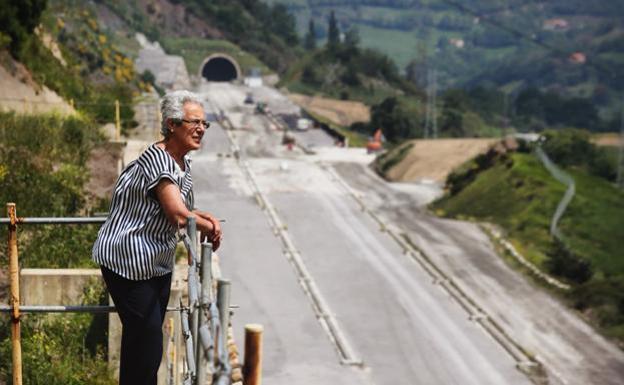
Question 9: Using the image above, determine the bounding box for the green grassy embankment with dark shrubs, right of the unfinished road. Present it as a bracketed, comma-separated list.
[431, 147, 624, 341]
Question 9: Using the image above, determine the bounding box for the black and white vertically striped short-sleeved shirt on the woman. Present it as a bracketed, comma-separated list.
[93, 144, 193, 280]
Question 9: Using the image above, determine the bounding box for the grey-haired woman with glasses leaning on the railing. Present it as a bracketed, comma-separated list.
[93, 91, 221, 385]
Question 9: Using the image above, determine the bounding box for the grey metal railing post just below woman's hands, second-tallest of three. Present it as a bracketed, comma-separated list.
[195, 242, 212, 384]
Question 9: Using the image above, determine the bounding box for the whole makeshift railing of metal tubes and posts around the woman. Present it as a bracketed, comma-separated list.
[0, 203, 262, 385]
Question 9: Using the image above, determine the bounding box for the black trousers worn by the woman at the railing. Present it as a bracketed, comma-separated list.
[101, 266, 171, 385]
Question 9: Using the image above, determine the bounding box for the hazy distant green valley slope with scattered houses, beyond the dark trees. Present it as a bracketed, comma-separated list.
[269, 0, 624, 130]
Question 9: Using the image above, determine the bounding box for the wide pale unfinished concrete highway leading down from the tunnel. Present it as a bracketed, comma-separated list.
[192, 83, 624, 385]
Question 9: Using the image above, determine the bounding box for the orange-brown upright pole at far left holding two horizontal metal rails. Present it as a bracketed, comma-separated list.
[7, 203, 22, 385]
